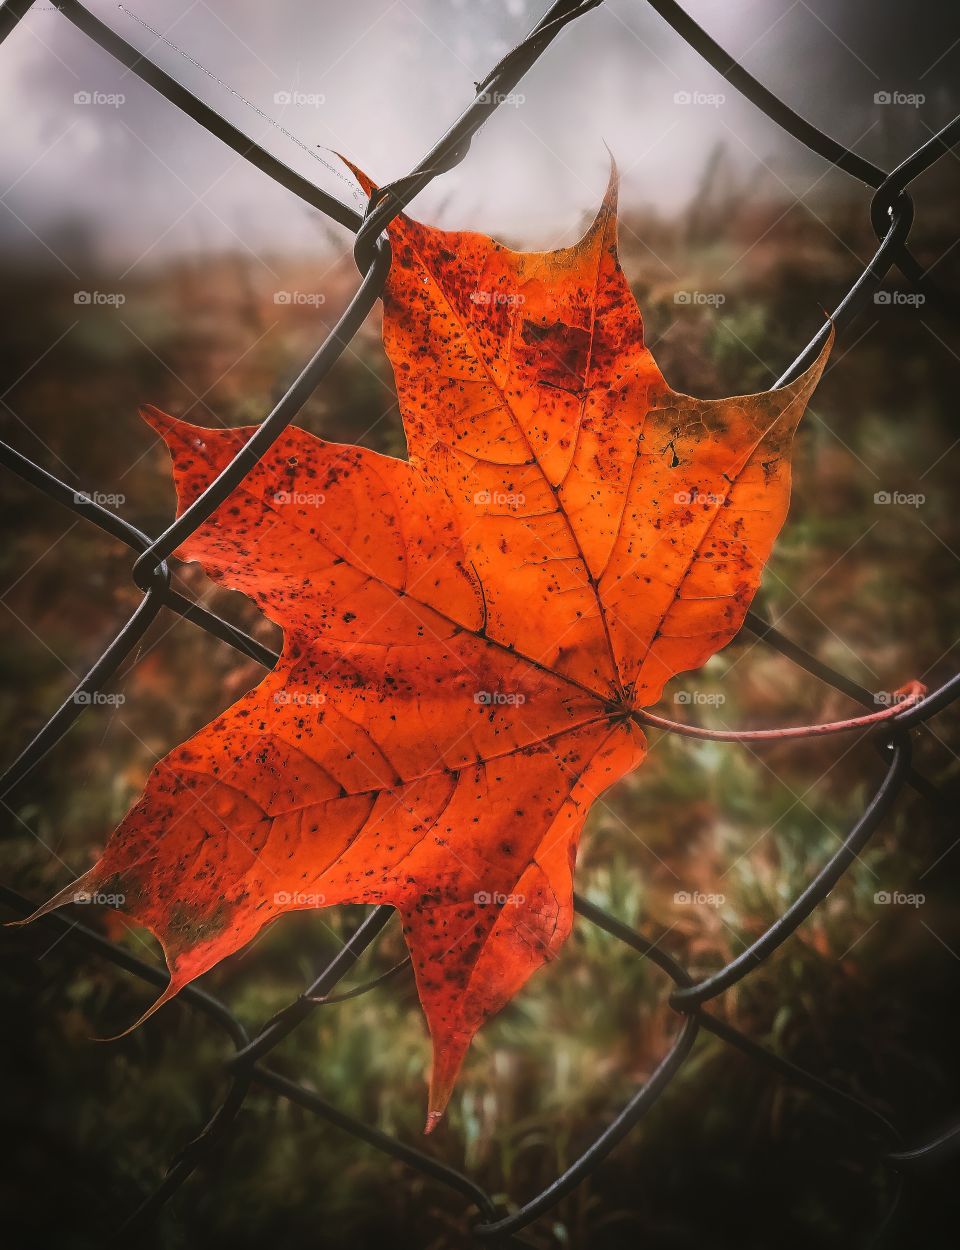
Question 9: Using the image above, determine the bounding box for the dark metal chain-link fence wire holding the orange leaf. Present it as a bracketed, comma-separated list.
[0, 0, 960, 1245]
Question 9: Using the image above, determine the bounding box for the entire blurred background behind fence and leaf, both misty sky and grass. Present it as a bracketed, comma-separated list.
[0, 0, 960, 1250]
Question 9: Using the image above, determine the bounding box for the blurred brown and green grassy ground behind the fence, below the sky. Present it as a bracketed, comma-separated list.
[0, 161, 960, 1250]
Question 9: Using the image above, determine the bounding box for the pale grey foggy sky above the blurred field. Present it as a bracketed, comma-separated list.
[0, 0, 960, 265]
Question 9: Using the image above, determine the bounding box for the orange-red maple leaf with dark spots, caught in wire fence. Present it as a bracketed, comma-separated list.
[24, 161, 829, 1128]
